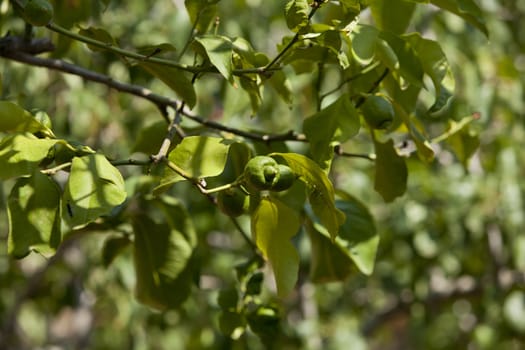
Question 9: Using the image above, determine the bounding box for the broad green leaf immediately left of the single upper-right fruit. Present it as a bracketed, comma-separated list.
[303, 94, 361, 170]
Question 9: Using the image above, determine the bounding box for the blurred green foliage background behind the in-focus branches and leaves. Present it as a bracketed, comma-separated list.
[0, 0, 525, 349]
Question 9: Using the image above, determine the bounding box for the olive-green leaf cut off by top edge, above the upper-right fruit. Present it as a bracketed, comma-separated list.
[370, 0, 416, 34]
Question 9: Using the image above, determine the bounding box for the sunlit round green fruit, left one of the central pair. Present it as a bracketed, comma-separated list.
[244, 156, 279, 191]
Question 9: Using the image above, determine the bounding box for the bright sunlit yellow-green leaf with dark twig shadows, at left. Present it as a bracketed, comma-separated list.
[62, 154, 126, 228]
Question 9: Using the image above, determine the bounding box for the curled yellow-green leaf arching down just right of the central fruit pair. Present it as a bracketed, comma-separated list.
[270, 153, 345, 239]
